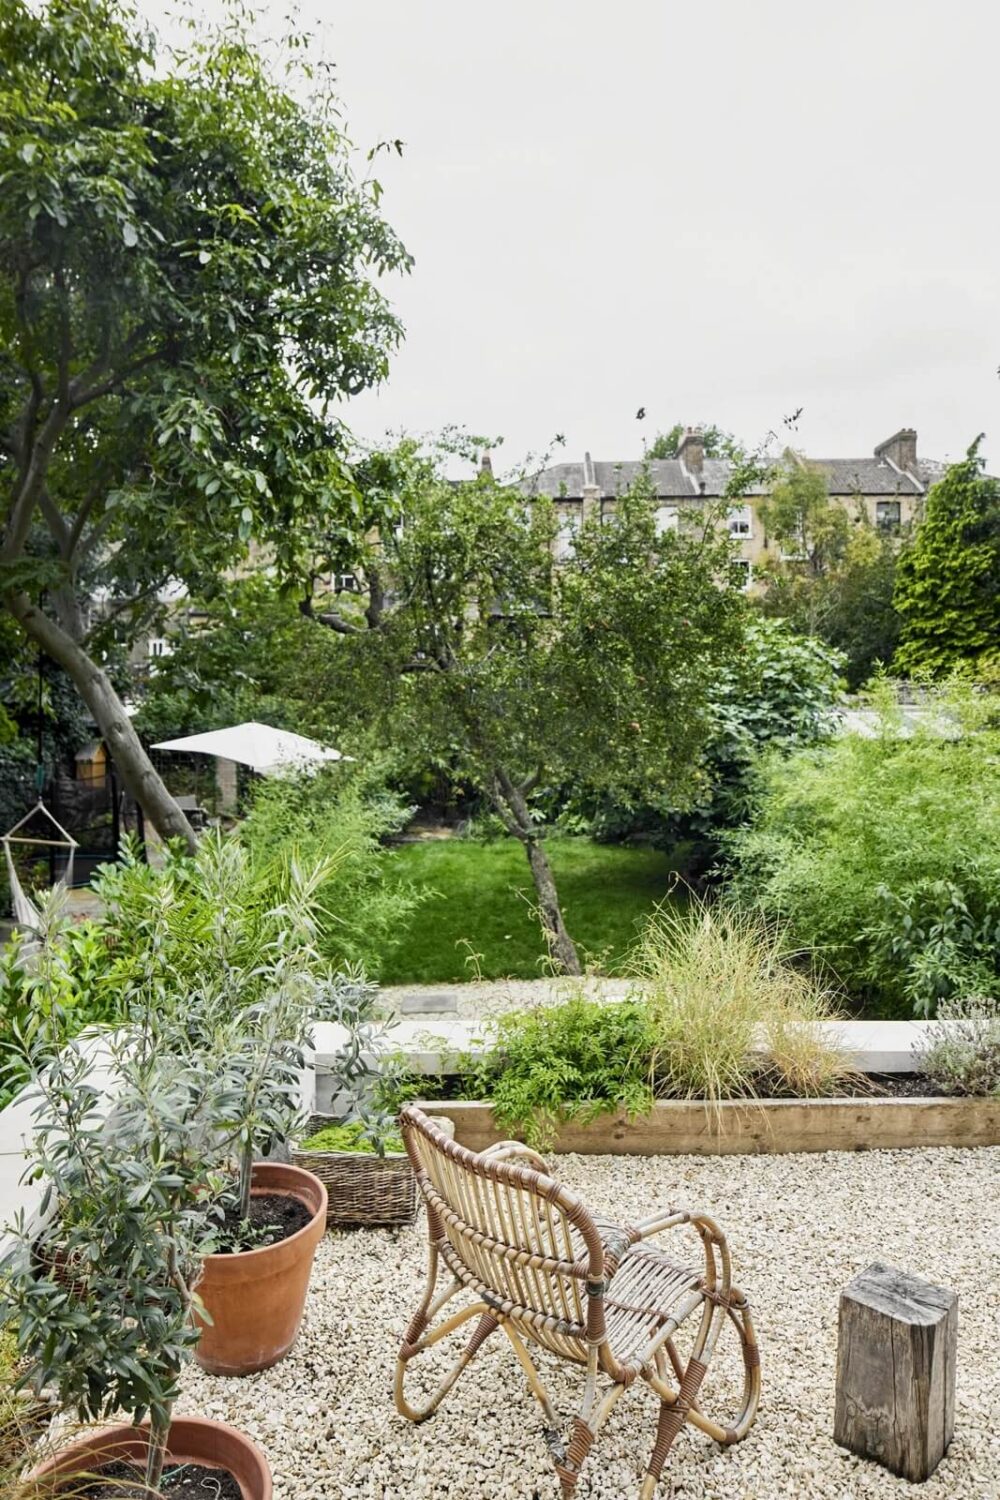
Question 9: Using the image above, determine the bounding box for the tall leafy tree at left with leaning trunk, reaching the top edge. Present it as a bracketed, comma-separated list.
[0, 0, 408, 845]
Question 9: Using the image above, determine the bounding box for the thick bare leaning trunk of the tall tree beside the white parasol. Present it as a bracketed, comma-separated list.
[6, 594, 198, 854]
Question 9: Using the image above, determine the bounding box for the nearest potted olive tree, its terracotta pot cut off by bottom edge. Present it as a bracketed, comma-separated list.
[0, 1034, 271, 1500]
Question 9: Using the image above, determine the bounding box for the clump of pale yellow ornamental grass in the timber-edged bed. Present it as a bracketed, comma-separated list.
[634, 903, 853, 1103]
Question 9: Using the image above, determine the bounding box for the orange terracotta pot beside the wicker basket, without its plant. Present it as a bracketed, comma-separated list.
[195, 1161, 327, 1376]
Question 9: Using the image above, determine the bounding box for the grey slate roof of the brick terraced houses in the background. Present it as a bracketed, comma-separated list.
[523, 458, 945, 501]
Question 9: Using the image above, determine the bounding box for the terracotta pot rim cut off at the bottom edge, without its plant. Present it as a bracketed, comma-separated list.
[34, 1416, 273, 1500]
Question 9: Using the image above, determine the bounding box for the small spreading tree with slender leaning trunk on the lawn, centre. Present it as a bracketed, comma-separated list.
[316, 453, 745, 974]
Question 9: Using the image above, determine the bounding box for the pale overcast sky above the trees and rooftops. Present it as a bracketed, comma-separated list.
[145, 0, 1000, 462]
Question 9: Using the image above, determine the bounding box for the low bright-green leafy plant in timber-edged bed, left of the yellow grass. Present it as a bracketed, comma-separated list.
[477, 995, 652, 1148]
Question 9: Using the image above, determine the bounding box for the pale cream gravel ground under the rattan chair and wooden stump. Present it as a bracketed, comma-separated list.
[180, 1149, 1000, 1500]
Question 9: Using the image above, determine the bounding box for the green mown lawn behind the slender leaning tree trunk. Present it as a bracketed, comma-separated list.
[379, 839, 683, 984]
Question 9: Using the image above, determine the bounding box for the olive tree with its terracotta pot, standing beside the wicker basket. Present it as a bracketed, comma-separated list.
[93, 836, 336, 1376]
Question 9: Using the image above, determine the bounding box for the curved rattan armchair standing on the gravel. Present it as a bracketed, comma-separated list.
[396, 1106, 760, 1500]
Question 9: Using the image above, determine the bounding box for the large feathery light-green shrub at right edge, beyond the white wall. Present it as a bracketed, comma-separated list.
[727, 702, 1000, 1016]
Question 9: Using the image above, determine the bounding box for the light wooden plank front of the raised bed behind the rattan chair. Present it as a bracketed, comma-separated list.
[420, 1098, 1000, 1157]
